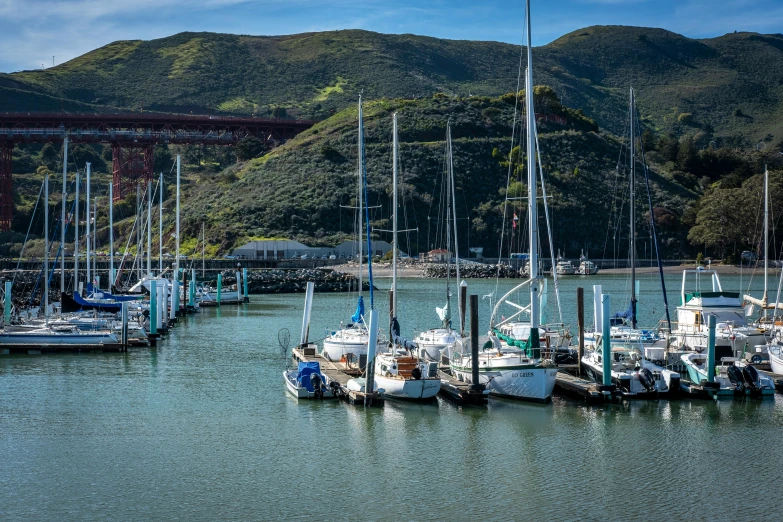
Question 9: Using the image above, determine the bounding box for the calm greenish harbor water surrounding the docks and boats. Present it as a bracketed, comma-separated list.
[0, 275, 783, 521]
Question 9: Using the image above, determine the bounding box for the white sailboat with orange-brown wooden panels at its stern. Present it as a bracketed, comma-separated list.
[375, 113, 440, 400]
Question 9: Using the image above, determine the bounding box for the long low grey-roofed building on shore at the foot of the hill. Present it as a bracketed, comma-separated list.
[231, 239, 391, 261]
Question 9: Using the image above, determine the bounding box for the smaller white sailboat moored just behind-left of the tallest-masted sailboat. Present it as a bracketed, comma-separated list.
[416, 122, 462, 361]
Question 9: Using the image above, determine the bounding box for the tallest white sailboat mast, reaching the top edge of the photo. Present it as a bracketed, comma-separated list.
[525, 0, 540, 328]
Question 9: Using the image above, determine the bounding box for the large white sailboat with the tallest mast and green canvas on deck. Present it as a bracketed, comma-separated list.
[449, 0, 558, 402]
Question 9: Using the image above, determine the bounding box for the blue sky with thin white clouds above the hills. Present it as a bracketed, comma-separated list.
[0, 0, 783, 72]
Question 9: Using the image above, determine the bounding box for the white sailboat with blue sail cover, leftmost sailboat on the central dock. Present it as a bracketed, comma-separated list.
[321, 96, 382, 362]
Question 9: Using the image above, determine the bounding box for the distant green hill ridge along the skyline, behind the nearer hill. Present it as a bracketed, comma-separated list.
[0, 26, 783, 144]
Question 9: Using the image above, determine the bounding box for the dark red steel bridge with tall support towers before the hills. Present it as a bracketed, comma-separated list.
[0, 113, 315, 231]
